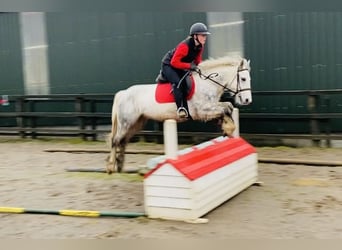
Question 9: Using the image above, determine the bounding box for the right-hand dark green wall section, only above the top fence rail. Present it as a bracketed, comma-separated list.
[245, 12, 342, 90]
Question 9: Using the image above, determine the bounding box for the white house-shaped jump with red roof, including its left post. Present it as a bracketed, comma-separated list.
[144, 120, 258, 223]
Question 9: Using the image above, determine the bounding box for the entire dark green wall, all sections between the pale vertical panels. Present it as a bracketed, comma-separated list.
[0, 12, 342, 133]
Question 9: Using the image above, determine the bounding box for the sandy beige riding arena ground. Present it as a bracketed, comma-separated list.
[0, 138, 342, 239]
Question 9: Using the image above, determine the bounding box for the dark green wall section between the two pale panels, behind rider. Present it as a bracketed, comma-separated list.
[46, 12, 205, 94]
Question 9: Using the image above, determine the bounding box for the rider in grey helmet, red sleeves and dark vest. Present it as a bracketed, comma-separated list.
[161, 23, 210, 118]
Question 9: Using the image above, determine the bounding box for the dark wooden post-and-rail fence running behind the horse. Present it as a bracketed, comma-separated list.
[0, 89, 342, 146]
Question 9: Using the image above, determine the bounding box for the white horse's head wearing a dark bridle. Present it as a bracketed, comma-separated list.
[234, 59, 252, 105]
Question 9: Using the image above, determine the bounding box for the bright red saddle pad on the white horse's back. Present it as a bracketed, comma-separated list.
[155, 72, 195, 103]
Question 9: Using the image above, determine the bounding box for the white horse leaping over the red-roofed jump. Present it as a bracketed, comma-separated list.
[106, 56, 252, 174]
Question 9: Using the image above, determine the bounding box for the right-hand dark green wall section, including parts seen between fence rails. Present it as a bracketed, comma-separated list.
[242, 12, 342, 133]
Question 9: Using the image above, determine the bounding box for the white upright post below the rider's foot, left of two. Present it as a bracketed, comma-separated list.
[164, 119, 178, 159]
